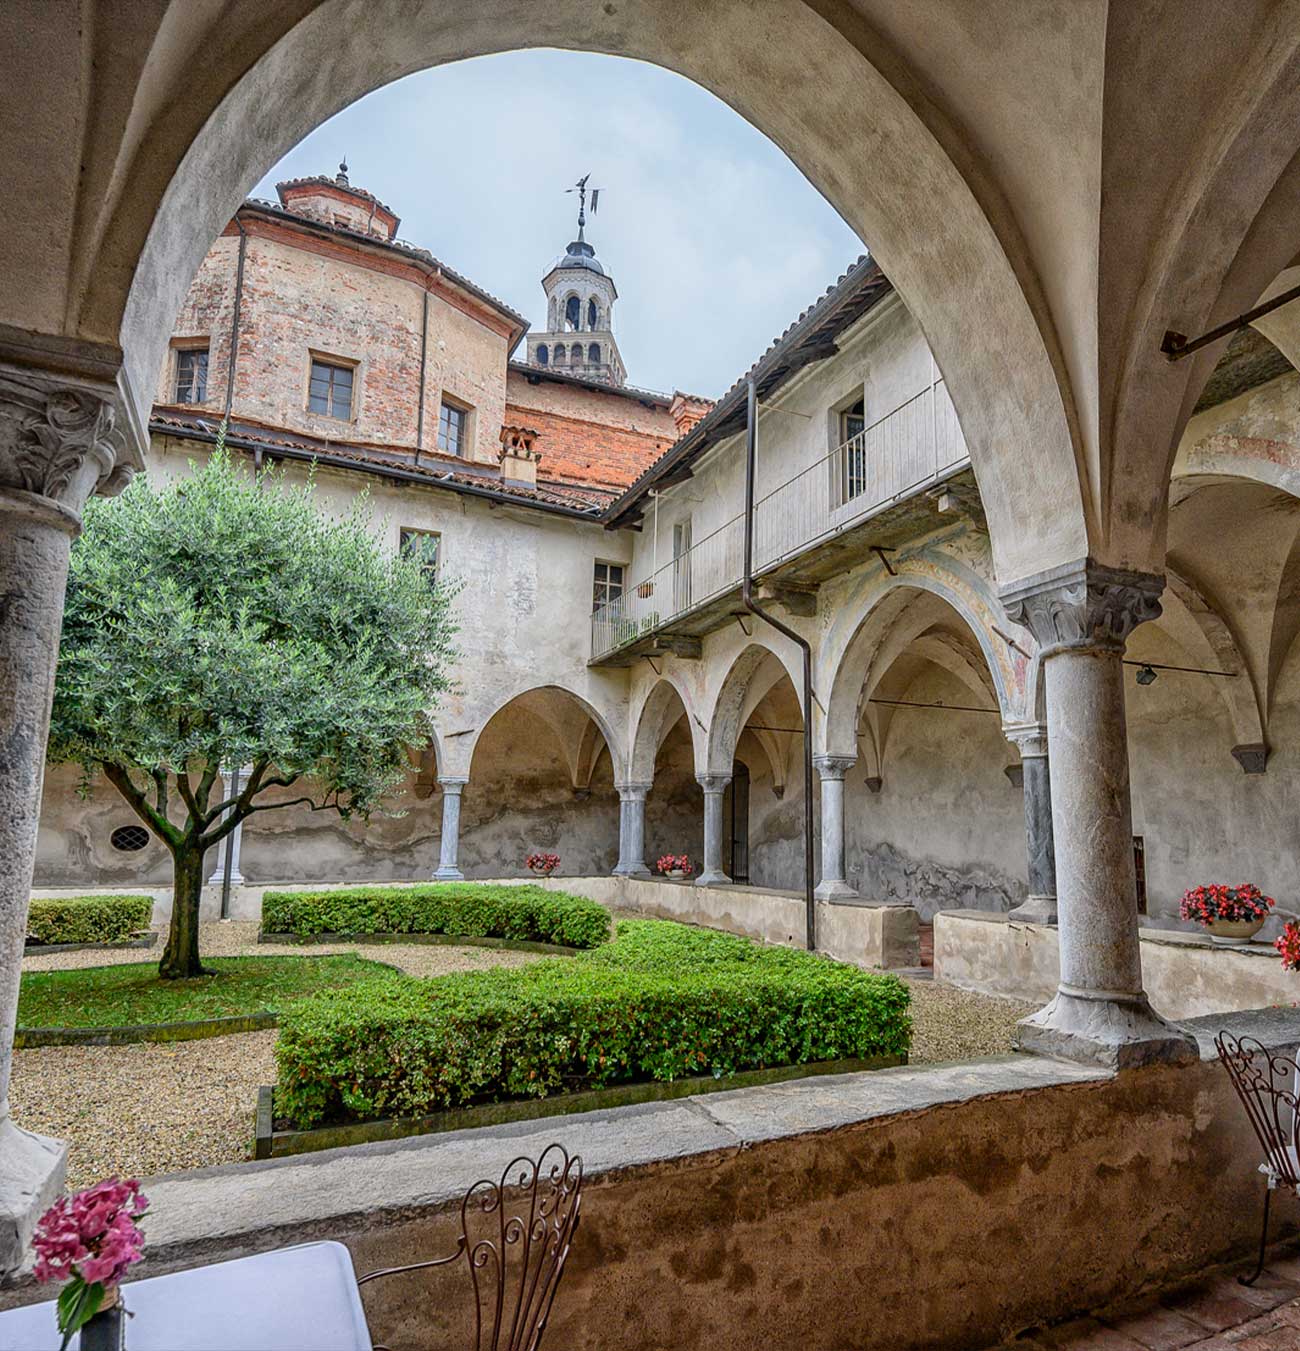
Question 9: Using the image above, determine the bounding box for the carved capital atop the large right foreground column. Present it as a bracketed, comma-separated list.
[1001, 561, 1165, 657]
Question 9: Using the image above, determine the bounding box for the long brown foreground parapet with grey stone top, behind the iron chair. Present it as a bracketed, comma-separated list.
[0, 1011, 1300, 1351]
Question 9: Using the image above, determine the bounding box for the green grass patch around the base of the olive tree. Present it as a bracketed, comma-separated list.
[18, 955, 399, 1027]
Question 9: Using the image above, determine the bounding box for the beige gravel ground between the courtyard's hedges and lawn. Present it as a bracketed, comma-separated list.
[9, 920, 1032, 1186]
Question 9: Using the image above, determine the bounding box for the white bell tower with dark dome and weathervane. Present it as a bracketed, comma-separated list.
[528, 174, 627, 385]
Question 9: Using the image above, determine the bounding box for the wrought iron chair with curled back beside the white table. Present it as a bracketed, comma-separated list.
[357, 1144, 582, 1351]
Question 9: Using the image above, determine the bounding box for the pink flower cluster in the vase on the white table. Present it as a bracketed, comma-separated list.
[32, 1178, 149, 1288]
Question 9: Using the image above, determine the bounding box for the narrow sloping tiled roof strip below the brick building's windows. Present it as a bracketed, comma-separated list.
[149, 404, 616, 520]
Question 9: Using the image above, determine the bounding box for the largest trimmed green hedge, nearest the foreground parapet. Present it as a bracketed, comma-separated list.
[276, 920, 911, 1129]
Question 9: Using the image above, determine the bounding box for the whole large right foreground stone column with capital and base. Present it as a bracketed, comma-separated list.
[1003, 562, 1197, 1069]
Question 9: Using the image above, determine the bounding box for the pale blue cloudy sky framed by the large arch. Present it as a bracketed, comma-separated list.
[254, 51, 861, 396]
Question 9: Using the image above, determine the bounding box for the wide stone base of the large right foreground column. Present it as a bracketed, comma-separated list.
[1014, 990, 1200, 1070]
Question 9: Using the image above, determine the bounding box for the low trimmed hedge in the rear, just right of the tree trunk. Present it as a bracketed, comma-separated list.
[262, 882, 609, 947]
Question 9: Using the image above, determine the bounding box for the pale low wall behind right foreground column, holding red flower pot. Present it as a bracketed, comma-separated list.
[934, 911, 1300, 1019]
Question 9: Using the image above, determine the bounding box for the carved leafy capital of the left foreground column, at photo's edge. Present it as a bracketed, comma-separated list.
[0, 363, 136, 516]
